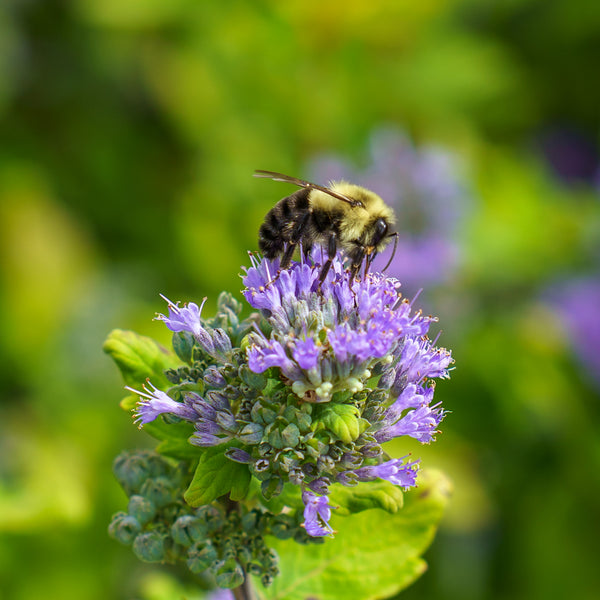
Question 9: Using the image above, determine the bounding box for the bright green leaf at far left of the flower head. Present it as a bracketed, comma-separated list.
[102, 329, 181, 388]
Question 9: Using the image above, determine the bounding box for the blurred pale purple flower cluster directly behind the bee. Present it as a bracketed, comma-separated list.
[309, 128, 470, 290]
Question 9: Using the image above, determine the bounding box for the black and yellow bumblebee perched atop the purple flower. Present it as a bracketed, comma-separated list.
[254, 170, 398, 285]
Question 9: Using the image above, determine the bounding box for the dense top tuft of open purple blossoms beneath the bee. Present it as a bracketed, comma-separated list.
[243, 250, 452, 402]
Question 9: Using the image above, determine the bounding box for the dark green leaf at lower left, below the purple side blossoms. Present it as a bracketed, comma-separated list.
[183, 442, 250, 506]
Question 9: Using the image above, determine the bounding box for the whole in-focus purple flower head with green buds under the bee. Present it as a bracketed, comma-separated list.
[127, 249, 452, 537]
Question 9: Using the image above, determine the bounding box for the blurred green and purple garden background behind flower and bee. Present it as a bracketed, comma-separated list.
[0, 0, 600, 600]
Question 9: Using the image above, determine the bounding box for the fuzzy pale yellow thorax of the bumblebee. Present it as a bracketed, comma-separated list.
[310, 181, 395, 240]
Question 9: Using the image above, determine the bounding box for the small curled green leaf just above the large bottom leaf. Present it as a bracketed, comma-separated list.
[329, 481, 404, 515]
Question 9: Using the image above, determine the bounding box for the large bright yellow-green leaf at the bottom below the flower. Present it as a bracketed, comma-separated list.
[255, 471, 450, 600]
